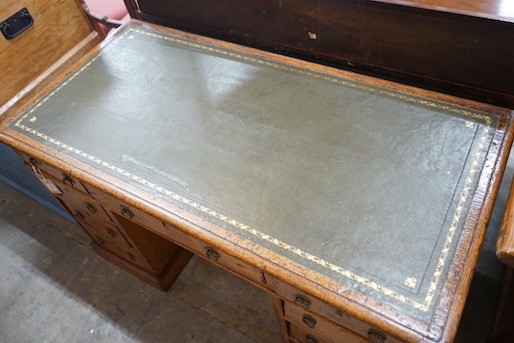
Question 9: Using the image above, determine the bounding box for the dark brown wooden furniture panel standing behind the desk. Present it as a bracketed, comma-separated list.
[127, 0, 514, 106]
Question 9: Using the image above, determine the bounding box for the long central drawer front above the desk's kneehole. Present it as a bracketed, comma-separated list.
[93, 189, 265, 286]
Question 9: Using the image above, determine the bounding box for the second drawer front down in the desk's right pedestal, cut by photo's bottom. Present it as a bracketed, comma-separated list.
[284, 301, 368, 343]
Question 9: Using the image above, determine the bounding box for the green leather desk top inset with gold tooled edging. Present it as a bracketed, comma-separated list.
[10, 26, 504, 322]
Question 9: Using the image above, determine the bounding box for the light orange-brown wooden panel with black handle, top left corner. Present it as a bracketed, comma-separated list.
[0, 0, 93, 106]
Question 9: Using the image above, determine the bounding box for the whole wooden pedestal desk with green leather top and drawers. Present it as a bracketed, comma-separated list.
[0, 21, 512, 343]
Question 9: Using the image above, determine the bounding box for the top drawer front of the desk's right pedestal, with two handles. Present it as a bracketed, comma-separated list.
[270, 278, 402, 343]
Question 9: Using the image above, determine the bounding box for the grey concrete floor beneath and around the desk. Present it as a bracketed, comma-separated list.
[0, 150, 512, 343]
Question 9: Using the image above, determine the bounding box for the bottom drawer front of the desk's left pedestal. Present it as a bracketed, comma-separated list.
[80, 223, 153, 273]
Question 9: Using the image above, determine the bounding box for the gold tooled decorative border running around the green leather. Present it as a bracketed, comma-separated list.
[15, 27, 492, 312]
